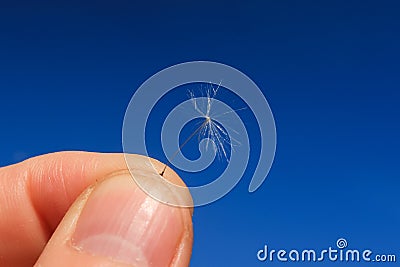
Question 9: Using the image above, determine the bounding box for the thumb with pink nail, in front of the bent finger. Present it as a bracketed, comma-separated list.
[36, 170, 193, 267]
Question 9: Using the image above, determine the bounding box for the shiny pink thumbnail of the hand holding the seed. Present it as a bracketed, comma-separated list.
[72, 172, 184, 266]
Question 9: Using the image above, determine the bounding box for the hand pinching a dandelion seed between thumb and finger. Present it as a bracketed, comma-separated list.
[0, 152, 193, 267]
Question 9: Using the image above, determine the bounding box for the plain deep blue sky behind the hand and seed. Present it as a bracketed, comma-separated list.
[0, 0, 400, 266]
